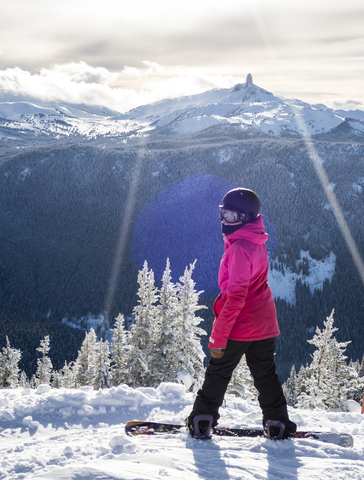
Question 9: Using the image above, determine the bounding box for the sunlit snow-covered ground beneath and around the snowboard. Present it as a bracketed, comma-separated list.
[0, 384, 364, 480]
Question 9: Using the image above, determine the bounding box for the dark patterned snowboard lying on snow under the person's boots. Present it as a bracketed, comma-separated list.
[125, 421, 354, 447]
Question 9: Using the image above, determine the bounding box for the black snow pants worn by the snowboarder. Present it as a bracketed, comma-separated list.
[190, 338, 296, 433]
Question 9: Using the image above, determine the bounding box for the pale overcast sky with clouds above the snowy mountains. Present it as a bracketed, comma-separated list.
[0, 0, 364, 111]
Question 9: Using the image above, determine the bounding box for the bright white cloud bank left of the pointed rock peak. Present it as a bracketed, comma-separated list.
[0, 60, 244, 112]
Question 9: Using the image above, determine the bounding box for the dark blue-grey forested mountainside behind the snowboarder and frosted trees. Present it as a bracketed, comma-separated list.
[0, 125, 364, 376]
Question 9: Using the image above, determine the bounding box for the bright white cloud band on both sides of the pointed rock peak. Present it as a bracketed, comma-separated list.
[0, 60, 364, 113]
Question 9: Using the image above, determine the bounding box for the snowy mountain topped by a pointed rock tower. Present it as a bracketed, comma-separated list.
[118, 74, 364, 135]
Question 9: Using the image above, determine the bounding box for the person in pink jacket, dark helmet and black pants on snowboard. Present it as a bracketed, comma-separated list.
[186, 188, 296, 438]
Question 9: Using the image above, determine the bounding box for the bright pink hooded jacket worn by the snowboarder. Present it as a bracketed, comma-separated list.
[209, 215, 279, 348]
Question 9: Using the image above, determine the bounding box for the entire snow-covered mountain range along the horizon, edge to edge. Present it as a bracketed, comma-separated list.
[0, 74, 364, 137]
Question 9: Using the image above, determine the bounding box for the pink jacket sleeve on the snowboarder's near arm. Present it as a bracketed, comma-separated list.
[209, 242, 252, 348]
